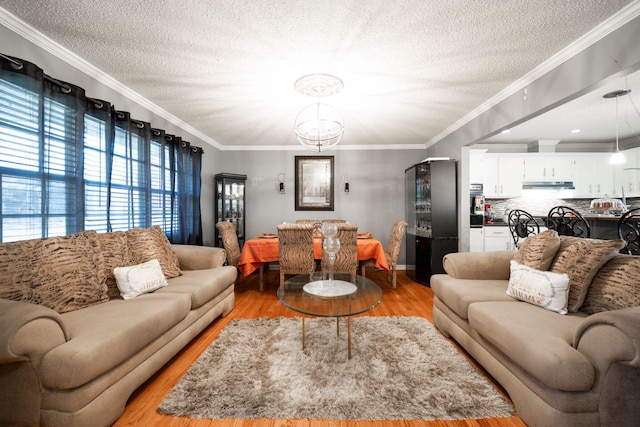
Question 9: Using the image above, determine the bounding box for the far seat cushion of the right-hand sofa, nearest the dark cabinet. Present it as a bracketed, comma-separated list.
[430, 274, 515, 320]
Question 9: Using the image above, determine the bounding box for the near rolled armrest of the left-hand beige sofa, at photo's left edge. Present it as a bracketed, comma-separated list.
[0, 299, 69, 364]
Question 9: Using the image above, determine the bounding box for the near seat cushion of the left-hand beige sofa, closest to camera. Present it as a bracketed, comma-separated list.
[39, 293, 191, 390]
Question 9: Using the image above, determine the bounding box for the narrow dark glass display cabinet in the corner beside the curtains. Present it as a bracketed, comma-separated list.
[214, 173, 247, 248]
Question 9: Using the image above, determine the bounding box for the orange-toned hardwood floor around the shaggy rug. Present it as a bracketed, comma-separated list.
[114, 271, 526, 427]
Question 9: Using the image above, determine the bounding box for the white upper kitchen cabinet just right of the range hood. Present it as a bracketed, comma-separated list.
[573, 153, 615, 199]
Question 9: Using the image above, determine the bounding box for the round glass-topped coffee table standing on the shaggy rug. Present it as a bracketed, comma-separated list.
[278, 272, 382, 359]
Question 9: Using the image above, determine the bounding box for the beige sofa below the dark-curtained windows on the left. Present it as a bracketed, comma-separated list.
[0, 228, 237, 427]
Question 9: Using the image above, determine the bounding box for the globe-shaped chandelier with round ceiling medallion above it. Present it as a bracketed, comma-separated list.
[294, 74, 344, 152]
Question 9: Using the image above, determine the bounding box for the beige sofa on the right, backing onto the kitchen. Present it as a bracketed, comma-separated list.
[431, 235, 640, 427]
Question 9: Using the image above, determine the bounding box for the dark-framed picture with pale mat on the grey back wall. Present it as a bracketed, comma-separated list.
[295, 156, 334, 211]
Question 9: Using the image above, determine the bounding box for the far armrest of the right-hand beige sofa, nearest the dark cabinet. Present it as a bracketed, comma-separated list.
[442, 251, 516, 280]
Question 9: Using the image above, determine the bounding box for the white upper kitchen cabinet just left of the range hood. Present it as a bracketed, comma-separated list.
[482, 156, 523, 198]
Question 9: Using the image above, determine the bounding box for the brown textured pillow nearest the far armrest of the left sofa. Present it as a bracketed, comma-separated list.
[126, 225, 181, 279]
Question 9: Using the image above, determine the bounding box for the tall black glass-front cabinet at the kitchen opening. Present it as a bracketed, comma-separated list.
[405, 160, 458, 285]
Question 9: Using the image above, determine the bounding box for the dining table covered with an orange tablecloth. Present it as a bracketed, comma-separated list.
[238, 233, 389, 290]
